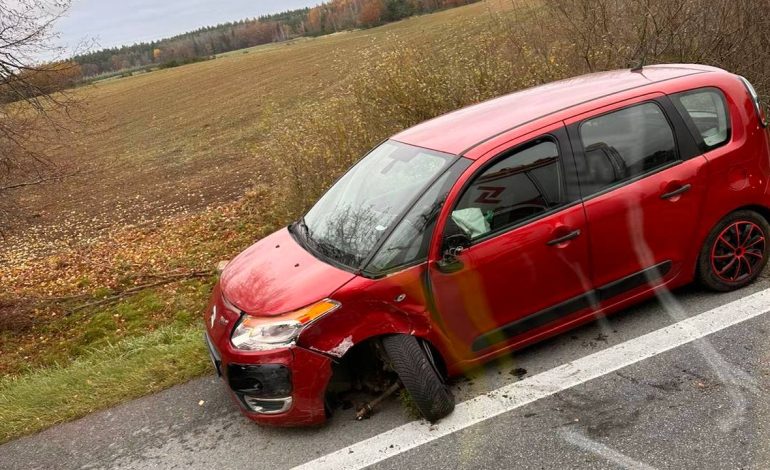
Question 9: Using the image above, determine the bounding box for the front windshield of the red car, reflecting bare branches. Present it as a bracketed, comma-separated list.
[293, 140, 456, 269]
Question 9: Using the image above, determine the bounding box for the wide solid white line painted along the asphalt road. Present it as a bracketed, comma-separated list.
[295, 289, 770, 470]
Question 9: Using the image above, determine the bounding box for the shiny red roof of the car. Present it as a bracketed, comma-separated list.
[393, 64, 727, 156]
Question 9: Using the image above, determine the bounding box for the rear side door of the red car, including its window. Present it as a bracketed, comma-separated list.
[567, 94, 706, 300]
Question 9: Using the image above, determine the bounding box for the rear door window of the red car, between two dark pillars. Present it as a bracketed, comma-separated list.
[576, 102, 679, 197]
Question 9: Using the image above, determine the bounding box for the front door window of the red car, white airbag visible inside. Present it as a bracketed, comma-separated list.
[450, 138, 567, 239]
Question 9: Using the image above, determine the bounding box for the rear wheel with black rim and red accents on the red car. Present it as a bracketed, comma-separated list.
[698, 210, 770, 292]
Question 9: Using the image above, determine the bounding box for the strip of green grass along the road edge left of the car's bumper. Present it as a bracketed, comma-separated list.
[0, 326, 210, 442]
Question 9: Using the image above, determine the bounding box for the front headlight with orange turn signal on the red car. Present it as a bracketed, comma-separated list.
[230, 299, 340, 351]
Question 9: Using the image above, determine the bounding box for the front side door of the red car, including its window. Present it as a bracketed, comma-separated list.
[429, 123, 591, 357]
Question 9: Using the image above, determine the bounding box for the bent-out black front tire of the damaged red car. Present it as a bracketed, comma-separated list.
[382, 335, 455, 423]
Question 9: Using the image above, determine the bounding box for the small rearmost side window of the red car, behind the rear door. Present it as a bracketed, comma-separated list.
[672, 88, 730, 151]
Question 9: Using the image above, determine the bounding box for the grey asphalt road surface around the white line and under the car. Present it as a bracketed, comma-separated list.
[0, 277, 770, 469]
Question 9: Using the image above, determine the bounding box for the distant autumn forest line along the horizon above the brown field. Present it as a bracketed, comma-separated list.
[72, 0, 479, 78]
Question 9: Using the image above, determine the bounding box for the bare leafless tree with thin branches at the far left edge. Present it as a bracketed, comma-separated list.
[0, 0, 79, 233]
